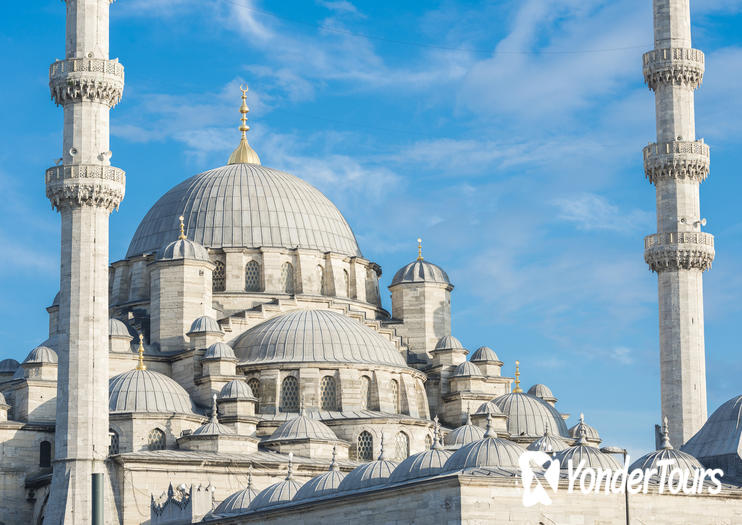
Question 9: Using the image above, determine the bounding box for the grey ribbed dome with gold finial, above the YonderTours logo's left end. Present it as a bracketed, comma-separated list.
[492, 392, 569, 438]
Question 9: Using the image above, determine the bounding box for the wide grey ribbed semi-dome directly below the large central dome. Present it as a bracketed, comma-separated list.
[234, 310, 407, 367]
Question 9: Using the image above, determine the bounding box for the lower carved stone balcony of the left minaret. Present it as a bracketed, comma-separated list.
[45, 164, 126, 212]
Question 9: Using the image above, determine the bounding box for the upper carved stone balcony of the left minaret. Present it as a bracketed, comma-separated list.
[49, 58, 124, 108]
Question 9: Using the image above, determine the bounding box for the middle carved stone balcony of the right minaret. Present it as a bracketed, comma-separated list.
[644, 139, 710, 184]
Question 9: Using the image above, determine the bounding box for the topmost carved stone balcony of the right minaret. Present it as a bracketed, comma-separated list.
[644, 47, 705, 91]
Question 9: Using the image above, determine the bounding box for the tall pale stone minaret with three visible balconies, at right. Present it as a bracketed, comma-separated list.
[644, 0, 714, 444]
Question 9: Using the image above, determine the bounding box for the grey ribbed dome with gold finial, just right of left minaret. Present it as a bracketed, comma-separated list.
[108, 370, 193, 414]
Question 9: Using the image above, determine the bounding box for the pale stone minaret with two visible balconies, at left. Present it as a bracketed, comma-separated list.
[44, 0, 125, 525]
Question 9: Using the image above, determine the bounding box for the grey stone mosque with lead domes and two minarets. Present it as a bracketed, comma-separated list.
[0, 0, 742, 525]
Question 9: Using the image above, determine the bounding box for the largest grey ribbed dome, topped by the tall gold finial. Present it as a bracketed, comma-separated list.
[126, 164, 361, 257]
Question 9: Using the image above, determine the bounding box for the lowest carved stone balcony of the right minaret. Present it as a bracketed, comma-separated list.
[644, 232, 715, 272]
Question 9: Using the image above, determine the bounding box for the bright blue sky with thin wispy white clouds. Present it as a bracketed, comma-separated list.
[0, 0, 742, 452]
